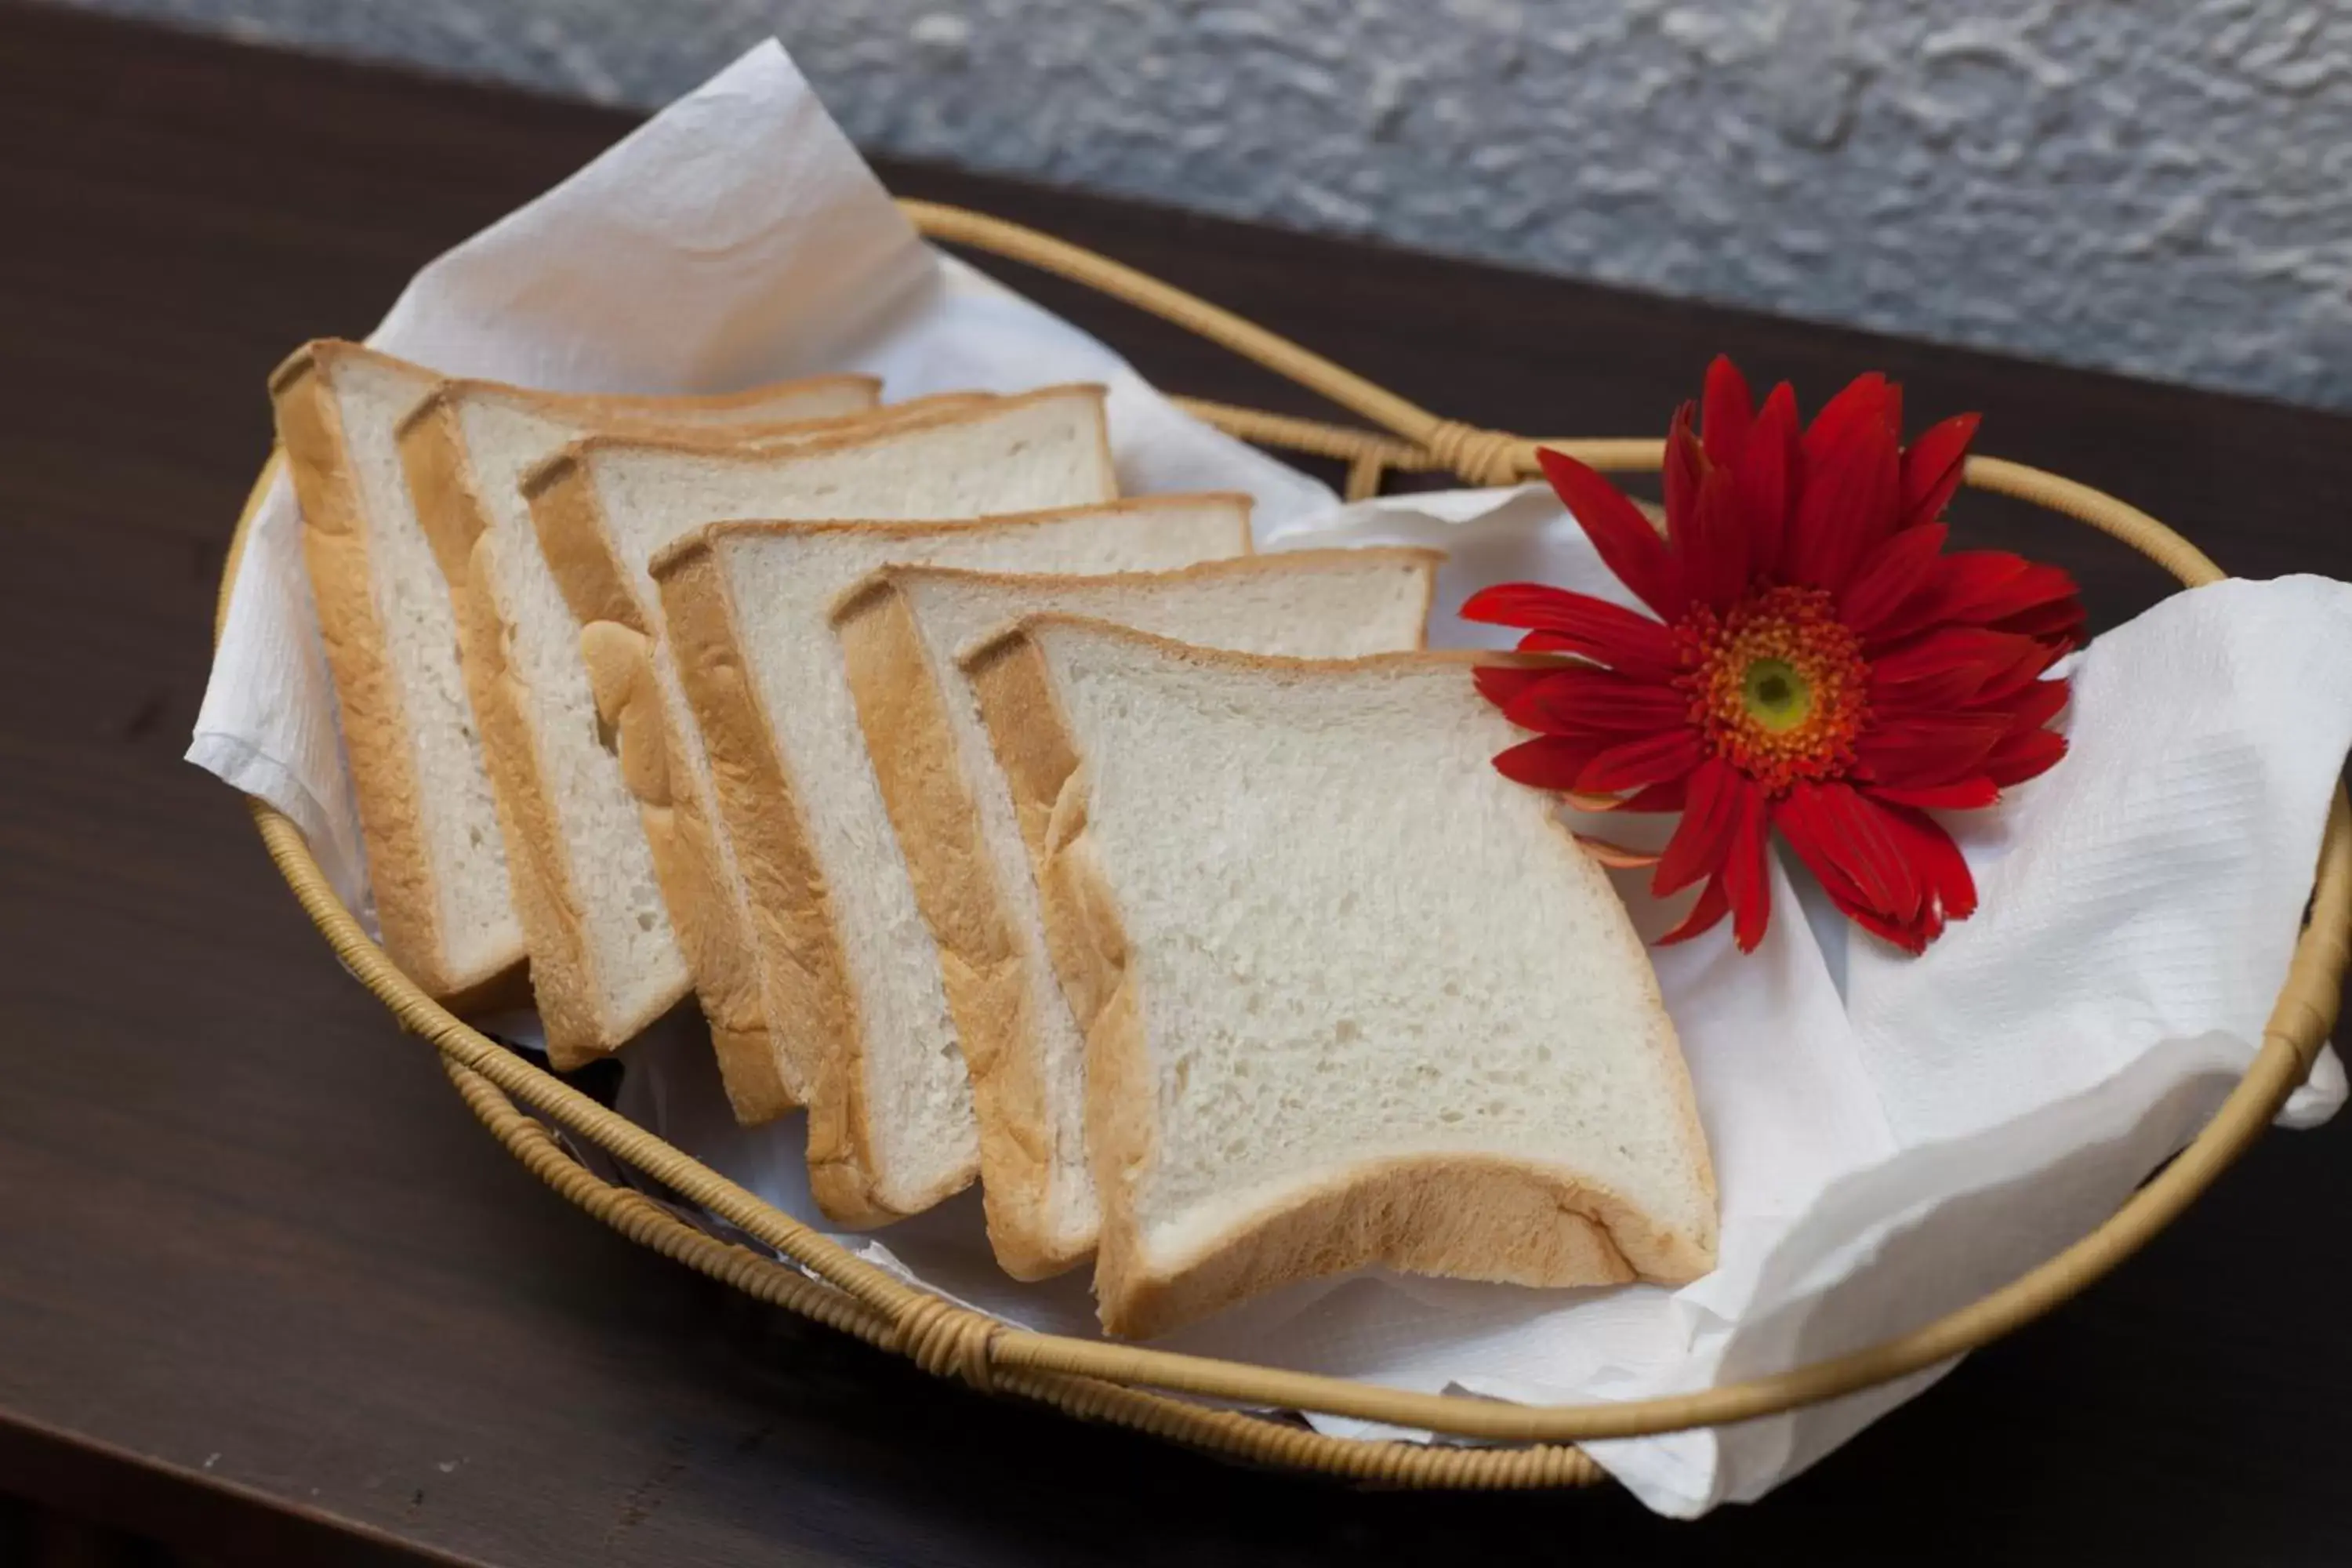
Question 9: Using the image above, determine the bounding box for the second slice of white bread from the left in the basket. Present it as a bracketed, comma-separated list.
[400, 376, 880, 1067]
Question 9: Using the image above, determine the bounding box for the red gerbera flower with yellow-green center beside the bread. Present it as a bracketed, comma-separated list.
[1463, 360, 2084, 952]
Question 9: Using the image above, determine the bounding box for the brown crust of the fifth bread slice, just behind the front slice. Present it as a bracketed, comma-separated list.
[833, 539, 1444, 1279]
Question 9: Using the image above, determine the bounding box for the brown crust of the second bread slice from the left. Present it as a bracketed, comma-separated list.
[397, 376, 880, 1069]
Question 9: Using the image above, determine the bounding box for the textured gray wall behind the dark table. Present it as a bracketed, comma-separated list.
[78, 0, 2352, 407]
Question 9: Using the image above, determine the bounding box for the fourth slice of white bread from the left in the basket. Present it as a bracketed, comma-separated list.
[654, 496, 1249, 1225]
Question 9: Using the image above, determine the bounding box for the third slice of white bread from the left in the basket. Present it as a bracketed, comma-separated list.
[524, 386, 1117, 1123]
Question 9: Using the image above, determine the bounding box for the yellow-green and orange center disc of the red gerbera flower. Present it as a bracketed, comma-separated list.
[1675, 586, 1870, 794]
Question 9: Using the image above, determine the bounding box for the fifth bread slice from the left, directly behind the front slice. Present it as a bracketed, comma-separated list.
[835, 550, 1442, 1279]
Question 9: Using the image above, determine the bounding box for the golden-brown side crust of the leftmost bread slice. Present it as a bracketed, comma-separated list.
[270, 341, 522, 1004]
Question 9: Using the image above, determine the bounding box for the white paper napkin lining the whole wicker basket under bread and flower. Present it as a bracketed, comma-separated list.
[188, 45, 2352, 1514]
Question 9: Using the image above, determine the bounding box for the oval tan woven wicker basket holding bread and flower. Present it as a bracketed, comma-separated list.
[221, 202, 2352, 1488]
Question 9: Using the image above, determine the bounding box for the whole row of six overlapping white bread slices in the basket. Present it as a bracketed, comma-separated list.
[270, 341, 1715, 1335]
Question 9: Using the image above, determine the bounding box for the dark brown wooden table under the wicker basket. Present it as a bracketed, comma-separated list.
[0, 9, 2352, 1563]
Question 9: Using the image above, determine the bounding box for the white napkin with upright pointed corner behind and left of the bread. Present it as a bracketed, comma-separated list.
[188, 42, 1336, 914]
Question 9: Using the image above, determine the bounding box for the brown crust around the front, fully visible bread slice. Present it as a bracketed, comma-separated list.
[964, 616, 1715, 1338]
